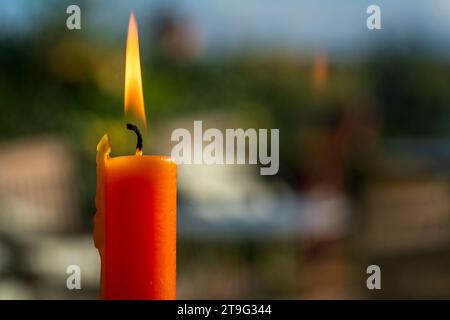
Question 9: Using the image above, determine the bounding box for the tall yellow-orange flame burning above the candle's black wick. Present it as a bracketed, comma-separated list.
[125, 13, 147, 128]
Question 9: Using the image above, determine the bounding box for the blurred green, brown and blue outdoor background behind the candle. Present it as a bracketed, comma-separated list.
[0, 0, 450, 299]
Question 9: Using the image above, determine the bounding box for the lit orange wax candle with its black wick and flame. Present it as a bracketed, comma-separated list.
[94, 15, 177, 299]
